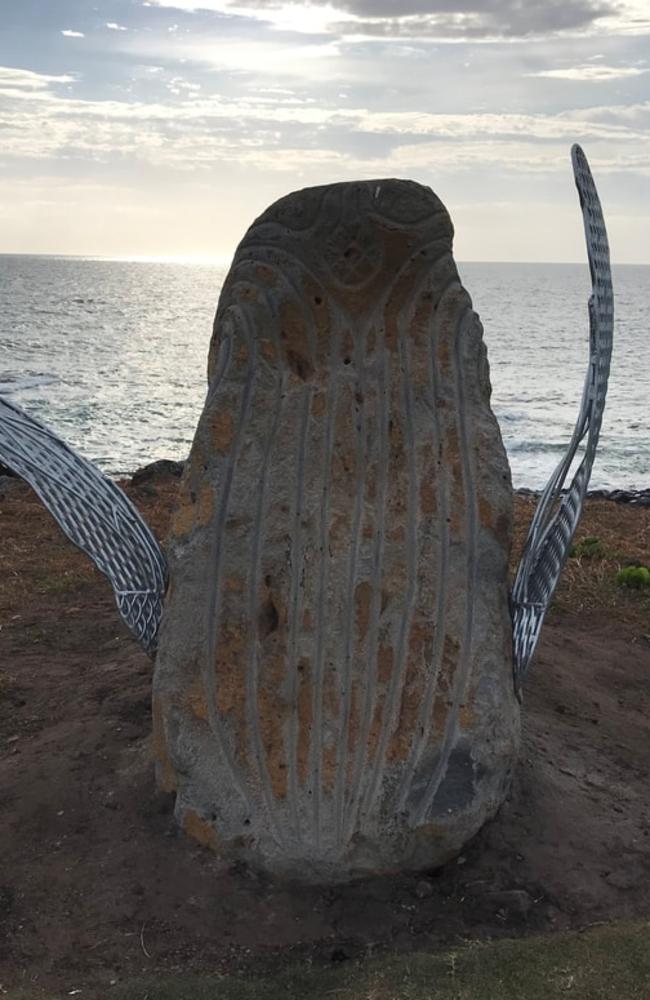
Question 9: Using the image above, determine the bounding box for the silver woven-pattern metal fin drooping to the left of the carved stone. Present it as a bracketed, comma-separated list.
[0, 397, 167, 653]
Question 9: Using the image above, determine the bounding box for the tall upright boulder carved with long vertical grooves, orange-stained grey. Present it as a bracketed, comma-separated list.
[154, 180, 519, 880]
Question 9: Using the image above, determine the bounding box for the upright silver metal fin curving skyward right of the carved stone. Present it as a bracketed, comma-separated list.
[512, 146, 614, 690]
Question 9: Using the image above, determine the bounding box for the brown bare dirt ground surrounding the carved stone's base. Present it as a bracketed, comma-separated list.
[0, 478, 650, 992]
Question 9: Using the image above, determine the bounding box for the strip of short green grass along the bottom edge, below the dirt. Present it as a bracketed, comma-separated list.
[6, 923, 650, 1000]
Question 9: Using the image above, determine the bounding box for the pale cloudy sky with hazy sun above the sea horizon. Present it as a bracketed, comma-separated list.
[0, 0, 650, 263]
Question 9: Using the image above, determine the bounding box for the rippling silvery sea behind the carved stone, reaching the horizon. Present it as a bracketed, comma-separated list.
[0, 255, 650, 489]
